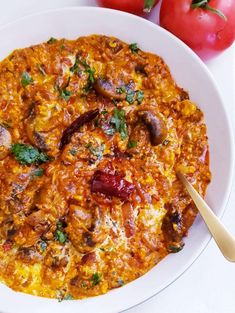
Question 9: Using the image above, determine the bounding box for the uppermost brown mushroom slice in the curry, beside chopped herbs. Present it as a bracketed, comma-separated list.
[94, 77, 126, 100]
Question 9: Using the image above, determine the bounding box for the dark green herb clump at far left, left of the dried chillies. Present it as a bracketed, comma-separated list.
[11, 143, 50, 165]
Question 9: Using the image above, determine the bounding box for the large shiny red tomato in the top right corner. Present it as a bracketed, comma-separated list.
[160, 0, 235, 60]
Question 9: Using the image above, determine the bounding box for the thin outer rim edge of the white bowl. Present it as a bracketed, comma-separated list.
[0, 4, 235, 313]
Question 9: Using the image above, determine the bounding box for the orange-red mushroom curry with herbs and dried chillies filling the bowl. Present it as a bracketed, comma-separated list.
[0, 35, 211, 300]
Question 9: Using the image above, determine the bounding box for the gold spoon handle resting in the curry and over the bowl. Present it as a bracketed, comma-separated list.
[177, 172, 235, 262]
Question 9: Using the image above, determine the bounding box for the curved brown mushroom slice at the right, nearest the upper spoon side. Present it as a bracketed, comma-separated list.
[138, 110, 167, 146]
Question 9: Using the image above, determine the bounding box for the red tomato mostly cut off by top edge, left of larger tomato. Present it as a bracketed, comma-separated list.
[97, 0, 159, 15]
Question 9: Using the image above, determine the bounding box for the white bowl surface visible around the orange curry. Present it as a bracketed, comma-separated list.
[0, 7, 233, 313]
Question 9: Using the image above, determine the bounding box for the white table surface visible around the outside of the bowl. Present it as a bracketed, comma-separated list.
[0, 0, 235, 313]
